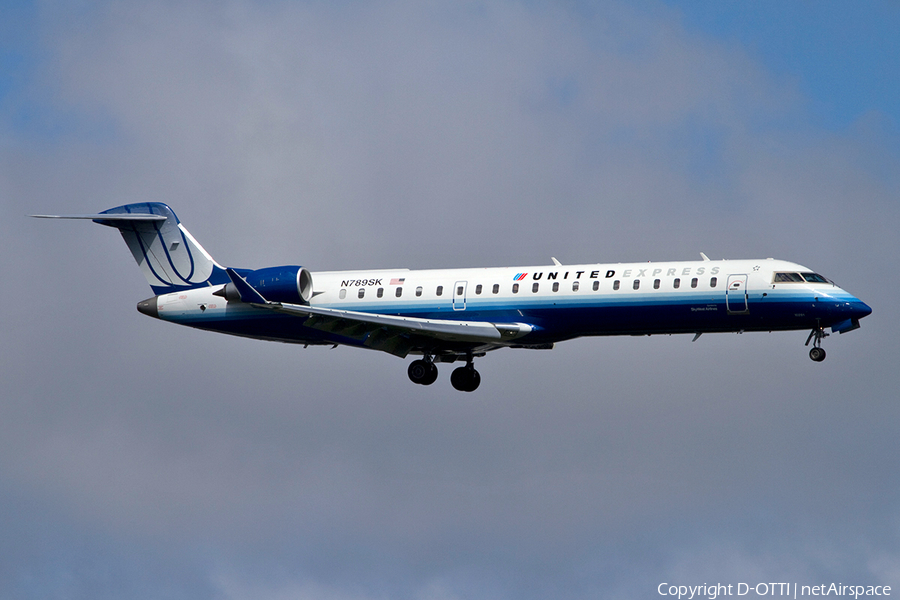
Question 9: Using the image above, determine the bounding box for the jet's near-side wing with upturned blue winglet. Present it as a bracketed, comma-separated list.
[226, 269, 534, 357]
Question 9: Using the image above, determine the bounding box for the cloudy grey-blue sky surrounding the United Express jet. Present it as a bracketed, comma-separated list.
[0, 0, 900, 600]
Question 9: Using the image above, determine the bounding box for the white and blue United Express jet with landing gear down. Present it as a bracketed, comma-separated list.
[31, 202, 872, 392]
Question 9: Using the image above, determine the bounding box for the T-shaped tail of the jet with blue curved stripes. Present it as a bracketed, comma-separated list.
[32, 202, 230, 295]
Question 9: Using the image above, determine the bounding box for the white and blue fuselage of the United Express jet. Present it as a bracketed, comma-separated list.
[143, 259, 871, 353]
